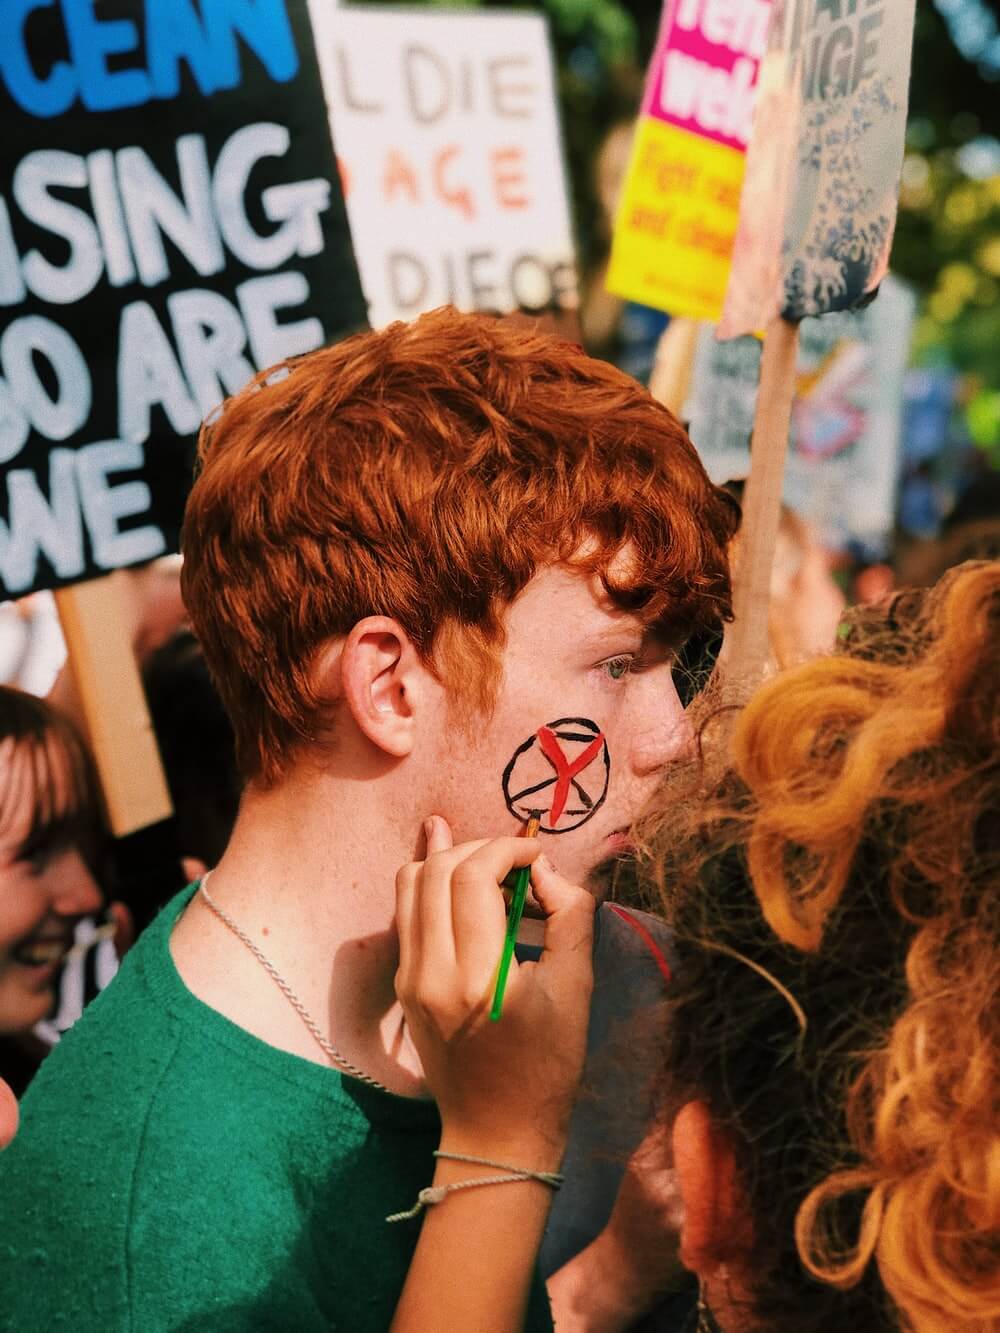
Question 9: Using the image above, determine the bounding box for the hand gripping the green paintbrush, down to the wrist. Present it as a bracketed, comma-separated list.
[396, 818, 593, 1169]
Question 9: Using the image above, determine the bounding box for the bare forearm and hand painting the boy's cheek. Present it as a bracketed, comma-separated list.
[392, 820, 593, 1333]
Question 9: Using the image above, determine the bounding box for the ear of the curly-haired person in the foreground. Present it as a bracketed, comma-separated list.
[673, 1101, 749, 1277]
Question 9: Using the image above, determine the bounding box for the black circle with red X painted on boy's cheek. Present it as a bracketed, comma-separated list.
[503, 717, 611, 833]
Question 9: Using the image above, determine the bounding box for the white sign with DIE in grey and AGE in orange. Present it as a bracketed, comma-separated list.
[309, 0, 577, 328]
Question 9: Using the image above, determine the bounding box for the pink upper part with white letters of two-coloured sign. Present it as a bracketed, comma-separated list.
[643, 0, 771, 151]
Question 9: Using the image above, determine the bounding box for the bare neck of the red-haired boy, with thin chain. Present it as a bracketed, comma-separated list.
[171, 773, 424, 1096]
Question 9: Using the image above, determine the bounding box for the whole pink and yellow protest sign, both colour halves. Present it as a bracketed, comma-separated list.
[608, 0, 771, 320]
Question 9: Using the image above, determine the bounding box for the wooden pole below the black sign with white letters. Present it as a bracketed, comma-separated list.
[55, 572, 172, 837]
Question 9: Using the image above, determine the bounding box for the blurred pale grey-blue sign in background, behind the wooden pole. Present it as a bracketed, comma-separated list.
[685, 277, 915, 552]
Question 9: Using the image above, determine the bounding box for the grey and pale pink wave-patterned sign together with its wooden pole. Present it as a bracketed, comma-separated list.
[719, 0, 913, 684]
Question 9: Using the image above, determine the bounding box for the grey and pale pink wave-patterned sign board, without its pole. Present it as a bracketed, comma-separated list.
[719, 0, 913, 337]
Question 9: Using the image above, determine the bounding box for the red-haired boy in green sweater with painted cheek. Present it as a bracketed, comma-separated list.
[0, 311, 735, 1333]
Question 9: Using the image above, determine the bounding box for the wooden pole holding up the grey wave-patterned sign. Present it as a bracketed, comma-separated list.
[723, 317, 799, 693]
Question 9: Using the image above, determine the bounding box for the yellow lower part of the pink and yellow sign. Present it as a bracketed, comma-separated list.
[607, 116, 745, 320]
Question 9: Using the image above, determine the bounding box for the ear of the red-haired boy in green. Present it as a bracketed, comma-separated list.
[331, 616, 424, 758]
